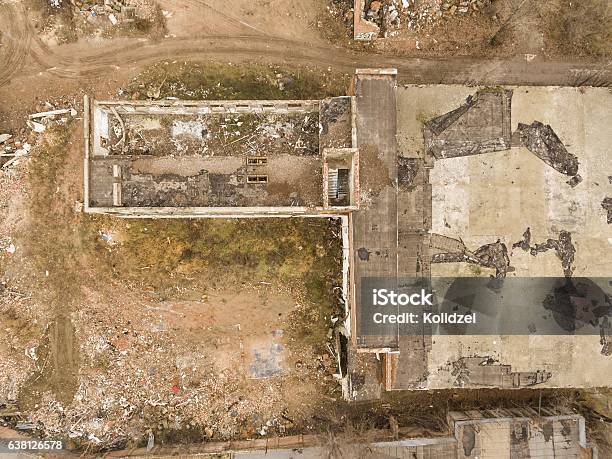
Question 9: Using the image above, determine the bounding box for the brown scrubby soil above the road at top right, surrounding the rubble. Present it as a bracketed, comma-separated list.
[324, 0, 612, 59]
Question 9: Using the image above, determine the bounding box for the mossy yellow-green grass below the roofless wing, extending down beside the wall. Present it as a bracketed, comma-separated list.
[100, 218, 342, 346]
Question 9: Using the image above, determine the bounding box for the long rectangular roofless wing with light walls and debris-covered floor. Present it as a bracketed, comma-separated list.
[86, 97, 359, 217]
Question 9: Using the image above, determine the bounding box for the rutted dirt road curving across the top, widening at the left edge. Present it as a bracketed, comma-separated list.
[0, 0, 612, 94]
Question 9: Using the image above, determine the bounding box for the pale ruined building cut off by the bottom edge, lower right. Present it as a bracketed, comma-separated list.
[210, 408, 601, 459]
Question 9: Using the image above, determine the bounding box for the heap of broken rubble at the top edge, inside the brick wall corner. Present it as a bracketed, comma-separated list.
[365, 0, 490, 37]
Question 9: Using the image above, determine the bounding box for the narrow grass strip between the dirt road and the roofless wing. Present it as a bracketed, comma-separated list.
[125, 61, 350, 100]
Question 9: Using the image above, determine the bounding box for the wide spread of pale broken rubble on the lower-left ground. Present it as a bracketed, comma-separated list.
[19, 282, 336, 451]
